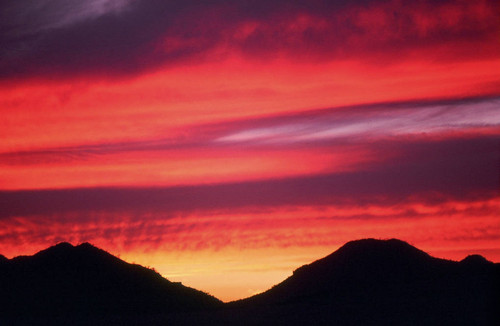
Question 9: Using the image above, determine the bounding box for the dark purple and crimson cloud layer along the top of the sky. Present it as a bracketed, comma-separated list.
[0, 0, 500, 78]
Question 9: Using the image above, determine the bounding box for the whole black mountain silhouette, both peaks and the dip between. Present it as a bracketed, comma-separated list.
[0, 239, 500, 325]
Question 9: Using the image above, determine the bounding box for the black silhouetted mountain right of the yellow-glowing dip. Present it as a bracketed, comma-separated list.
[230, 239, 500, 325]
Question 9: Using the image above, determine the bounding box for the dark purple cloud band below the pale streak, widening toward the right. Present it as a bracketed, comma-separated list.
[0, 136, 500, 218]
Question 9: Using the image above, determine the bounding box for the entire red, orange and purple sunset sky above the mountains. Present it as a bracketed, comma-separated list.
[0, 0, 500, 301]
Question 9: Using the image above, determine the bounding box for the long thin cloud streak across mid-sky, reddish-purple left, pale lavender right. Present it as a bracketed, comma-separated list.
[0, 97, 500, 164]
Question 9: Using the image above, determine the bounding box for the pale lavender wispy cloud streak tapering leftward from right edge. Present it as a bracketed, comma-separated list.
[215, 98, 500, 144]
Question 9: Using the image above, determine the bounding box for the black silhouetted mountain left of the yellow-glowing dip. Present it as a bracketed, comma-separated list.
[0, 243, 221, 320]
